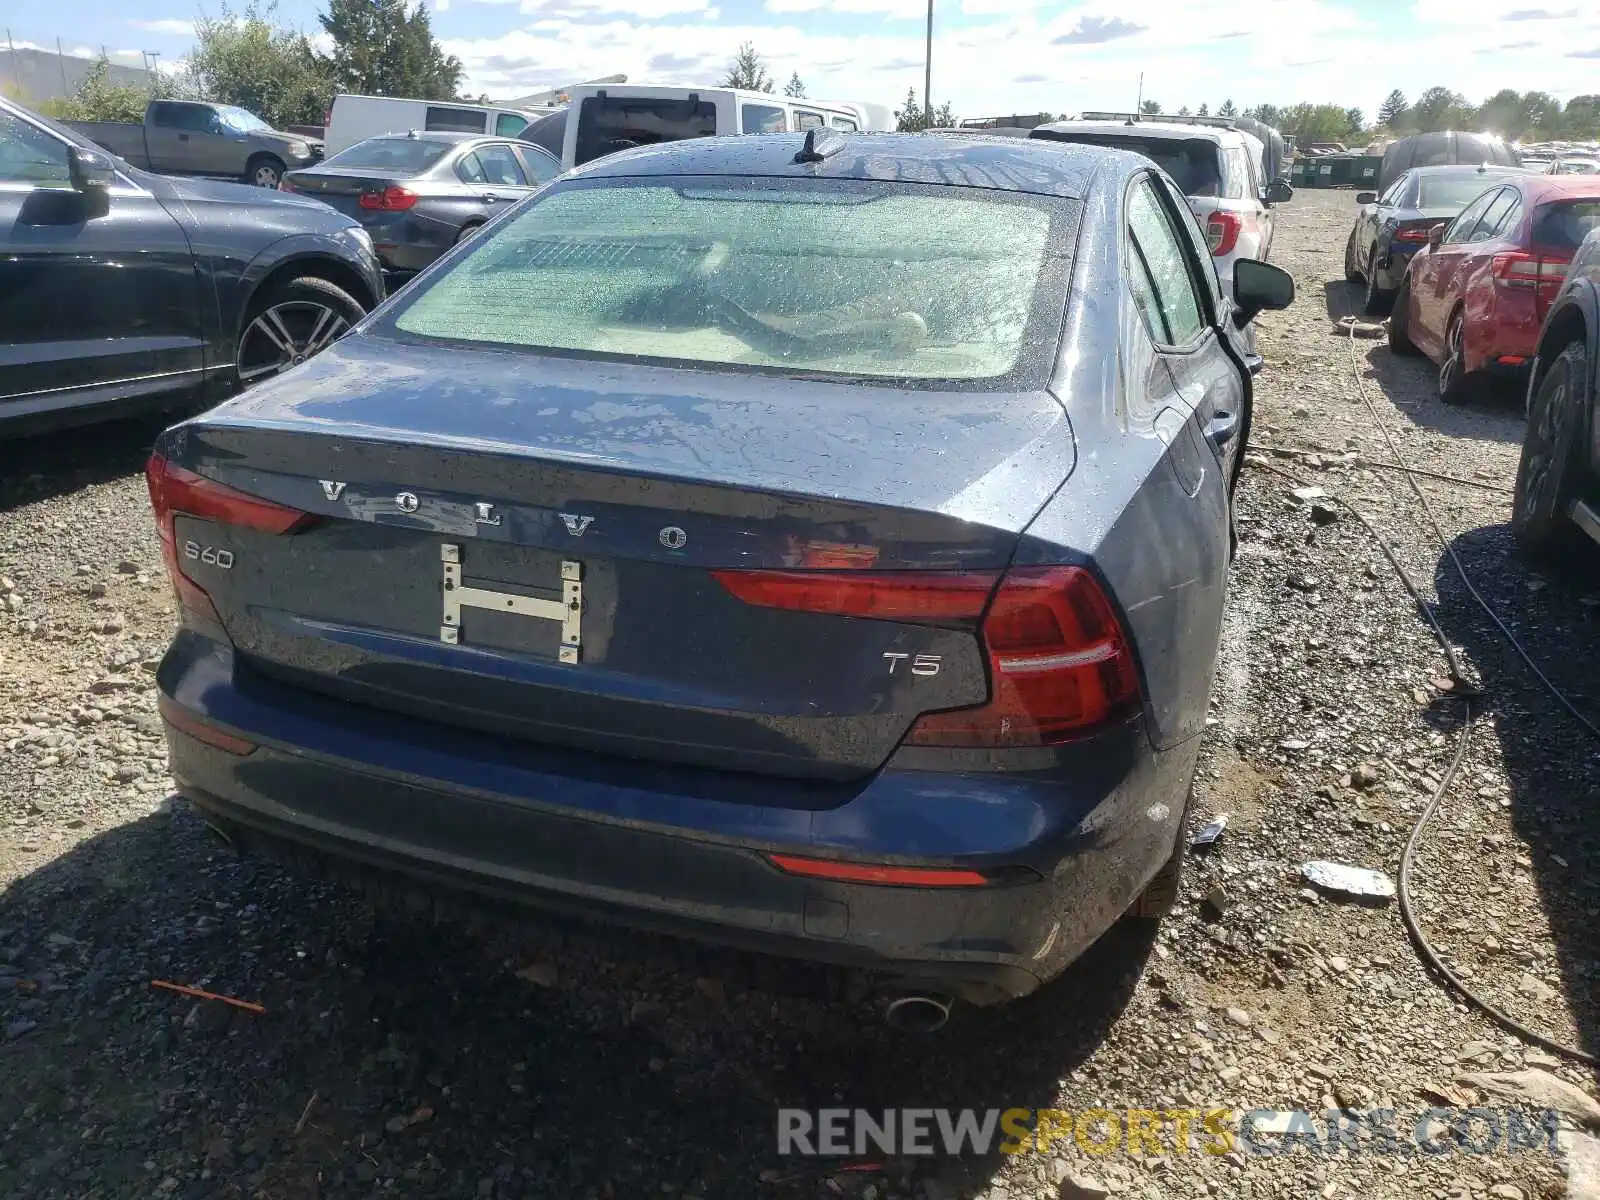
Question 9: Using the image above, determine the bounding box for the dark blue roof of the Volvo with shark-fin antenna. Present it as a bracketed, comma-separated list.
[578, 133, 1120, 200]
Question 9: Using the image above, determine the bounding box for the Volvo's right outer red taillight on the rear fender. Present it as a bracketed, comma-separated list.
[906, 566, 1139, 747]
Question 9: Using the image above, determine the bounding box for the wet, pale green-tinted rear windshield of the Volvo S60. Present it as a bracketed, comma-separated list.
[392, 178, 1077, 390]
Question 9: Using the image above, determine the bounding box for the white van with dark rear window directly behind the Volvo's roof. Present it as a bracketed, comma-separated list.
[553, 83, 890, 168]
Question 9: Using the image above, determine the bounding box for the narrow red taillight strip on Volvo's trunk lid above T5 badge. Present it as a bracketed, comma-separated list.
[712, 571, 1000, 622]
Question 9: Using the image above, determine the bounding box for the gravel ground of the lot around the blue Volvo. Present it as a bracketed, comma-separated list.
[0, 192, 1600, 1200]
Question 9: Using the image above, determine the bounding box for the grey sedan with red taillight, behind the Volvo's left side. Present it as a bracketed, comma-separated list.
[282, 130, 562, 277]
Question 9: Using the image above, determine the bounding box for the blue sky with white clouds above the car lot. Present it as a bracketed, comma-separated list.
[8, 0, 1600, 115]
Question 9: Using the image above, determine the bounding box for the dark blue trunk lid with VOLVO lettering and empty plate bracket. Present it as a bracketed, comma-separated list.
[160, 338, 1074, 778]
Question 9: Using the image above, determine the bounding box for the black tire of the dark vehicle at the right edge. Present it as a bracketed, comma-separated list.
[1510, 341, 1589, 560]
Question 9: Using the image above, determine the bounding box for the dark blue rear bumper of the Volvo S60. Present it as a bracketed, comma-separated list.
[158, 632, 1197, 1003]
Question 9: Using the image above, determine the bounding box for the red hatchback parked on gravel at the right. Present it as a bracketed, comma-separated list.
[1389, 174, 1600, 405]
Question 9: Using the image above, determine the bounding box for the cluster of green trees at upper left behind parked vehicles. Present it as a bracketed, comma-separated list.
[45, 0, 467, 128]
